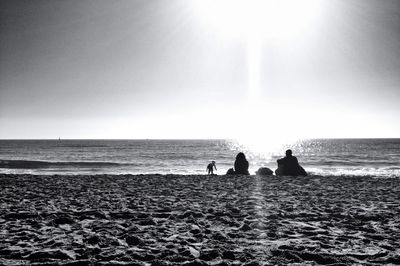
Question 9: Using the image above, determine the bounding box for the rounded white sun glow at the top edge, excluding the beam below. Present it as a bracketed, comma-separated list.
[194, 0, 322, 41]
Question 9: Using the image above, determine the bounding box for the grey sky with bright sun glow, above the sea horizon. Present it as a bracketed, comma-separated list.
[0, 0, 400, 141]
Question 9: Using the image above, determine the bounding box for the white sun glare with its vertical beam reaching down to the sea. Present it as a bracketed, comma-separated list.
[194, 0, 322, 153]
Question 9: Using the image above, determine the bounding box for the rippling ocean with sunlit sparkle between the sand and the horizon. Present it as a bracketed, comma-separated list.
[0, 139, 400, 177]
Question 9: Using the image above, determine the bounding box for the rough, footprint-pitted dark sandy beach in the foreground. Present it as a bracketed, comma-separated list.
[0, 175, 400, 265]
